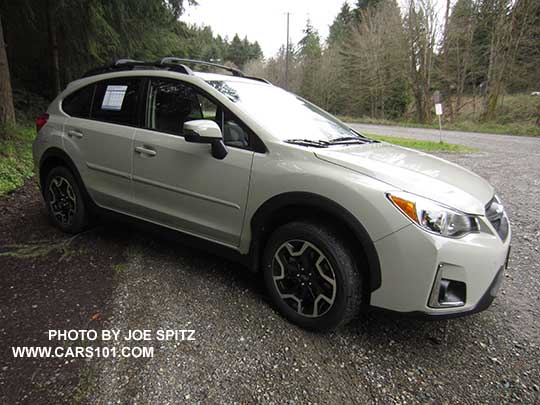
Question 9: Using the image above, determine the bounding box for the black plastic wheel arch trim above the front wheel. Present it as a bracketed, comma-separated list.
[250, 192, 381, 292]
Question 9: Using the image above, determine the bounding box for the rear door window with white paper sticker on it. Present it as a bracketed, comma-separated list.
[91, 78, 140, 125]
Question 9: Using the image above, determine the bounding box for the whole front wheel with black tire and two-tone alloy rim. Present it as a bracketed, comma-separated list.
[263, 221, 363, 331]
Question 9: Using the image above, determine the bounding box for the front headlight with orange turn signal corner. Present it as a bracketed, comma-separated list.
[387, 192, 480, 238]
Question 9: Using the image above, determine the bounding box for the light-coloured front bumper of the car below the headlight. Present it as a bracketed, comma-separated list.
[370, 221, 511, 318]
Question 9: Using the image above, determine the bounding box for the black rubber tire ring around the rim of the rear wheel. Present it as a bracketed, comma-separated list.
[45, 166, 88, 233]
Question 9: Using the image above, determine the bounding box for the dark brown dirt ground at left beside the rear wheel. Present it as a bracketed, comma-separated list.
[0, 181, 129, 403]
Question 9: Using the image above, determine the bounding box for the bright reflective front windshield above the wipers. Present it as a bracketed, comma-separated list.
[208, 80, 365, 142]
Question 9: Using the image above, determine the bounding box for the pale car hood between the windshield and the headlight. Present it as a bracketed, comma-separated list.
[315, 142, 494, 215]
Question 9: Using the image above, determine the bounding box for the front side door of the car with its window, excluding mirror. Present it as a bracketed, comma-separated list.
[132, 78, 253, 246]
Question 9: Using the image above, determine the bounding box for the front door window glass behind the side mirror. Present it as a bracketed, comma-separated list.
[146, 79, 211, 135]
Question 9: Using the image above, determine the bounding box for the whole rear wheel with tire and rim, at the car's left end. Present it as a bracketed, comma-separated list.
[44, 166, 88, 233]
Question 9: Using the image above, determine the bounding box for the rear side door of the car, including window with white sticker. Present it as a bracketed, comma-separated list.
[62, 77, 141, 212]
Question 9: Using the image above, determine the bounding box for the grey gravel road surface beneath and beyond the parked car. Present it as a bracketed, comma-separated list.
[0, 125, 540, 404]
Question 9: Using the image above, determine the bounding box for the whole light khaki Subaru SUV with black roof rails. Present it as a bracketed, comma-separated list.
[33, 58, 510, 330]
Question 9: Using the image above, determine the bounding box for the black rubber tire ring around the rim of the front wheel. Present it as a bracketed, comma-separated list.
[262, 223, 361, 331]
